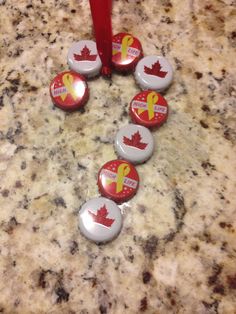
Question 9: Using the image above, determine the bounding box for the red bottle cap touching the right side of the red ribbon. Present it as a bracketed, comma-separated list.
[112, 33, 143, 72]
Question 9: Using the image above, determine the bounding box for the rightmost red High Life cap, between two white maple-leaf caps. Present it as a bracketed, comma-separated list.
[130, 90, 168, 128]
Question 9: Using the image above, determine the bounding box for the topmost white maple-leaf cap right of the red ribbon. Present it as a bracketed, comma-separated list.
[135, 56, 173, 92]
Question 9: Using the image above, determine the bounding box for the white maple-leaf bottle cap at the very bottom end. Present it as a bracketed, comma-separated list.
[79, 197, 122, 243]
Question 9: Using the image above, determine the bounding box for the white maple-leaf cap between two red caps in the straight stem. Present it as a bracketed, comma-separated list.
[115, 124, 154, 164]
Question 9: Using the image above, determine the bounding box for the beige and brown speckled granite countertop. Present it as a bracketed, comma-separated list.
[0, 0, 236, 314]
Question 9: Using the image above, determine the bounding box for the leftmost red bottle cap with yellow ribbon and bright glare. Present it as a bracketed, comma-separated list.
[50, 71, 89, 111]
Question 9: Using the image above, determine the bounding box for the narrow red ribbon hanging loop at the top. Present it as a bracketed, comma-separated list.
[89, 0, 112, 77]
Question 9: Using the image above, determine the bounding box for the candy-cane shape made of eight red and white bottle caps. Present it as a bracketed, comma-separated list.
[50, 33, 173, 242]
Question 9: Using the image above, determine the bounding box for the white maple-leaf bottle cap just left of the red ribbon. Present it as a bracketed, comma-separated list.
[67, 40, 102, 78]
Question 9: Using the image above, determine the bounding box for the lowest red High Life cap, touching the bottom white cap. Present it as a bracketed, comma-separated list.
[98, 160, 139, 203]
